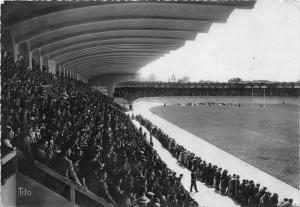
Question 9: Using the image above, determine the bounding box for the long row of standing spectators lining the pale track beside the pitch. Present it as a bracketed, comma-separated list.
[136, 115, 293, 207]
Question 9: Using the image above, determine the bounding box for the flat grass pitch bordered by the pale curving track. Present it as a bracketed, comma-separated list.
[151, 97, 299, 188]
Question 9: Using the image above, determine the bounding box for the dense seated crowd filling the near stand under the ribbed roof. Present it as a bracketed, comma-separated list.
[1, 50, 198, 207]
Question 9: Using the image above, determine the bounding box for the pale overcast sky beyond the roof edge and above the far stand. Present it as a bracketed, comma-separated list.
[141, 0, 300, 81]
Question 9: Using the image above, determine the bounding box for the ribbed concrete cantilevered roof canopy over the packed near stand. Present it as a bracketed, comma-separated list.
[2, 0, 255, 79]
